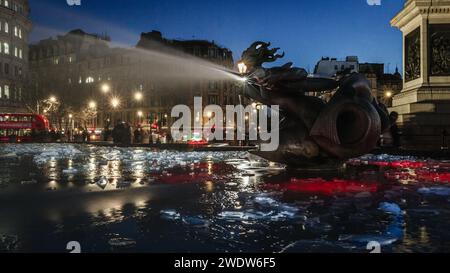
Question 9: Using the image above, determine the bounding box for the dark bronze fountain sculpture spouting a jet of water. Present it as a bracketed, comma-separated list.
[239, 42, 390, 167]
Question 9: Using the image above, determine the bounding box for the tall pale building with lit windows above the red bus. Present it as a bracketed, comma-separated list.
[0, 0, 32, 112]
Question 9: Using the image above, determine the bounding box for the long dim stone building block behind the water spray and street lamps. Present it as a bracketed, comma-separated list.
[30, 30, 239, 135]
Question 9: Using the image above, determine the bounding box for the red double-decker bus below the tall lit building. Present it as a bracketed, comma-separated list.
[0, 113, 50, 143]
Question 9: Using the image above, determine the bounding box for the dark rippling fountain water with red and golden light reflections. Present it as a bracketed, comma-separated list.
[0, 144, 450, 253]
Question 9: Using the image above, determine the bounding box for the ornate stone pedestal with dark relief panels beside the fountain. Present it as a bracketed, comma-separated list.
[390, 0, 450, 149]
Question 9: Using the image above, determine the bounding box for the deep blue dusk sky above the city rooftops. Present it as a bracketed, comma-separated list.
[29, 0, 404, 72]
